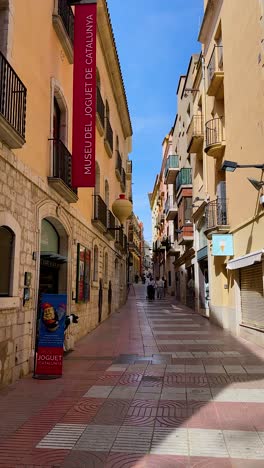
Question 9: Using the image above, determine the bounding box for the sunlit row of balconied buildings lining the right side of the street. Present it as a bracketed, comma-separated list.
[149, 0, 264, 346]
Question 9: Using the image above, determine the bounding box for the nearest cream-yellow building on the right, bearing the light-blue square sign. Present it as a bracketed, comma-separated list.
[193, 0, 264, 345]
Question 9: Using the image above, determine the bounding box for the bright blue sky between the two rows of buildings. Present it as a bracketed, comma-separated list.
[107, 0, 203, 241]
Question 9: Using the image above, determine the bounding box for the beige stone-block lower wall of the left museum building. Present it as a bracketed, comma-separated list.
[0, 145, 126, 385]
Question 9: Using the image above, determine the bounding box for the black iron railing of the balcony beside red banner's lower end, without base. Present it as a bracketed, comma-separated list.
[51, 139, 77, 194]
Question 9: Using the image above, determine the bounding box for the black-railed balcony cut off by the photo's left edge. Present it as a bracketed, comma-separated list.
[0, 52, 27, 149]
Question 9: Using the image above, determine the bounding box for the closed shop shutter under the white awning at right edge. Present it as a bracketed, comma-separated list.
[240, 263, 264, 330]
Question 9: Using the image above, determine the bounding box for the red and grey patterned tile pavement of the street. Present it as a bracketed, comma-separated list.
[0, 285, 264, 468]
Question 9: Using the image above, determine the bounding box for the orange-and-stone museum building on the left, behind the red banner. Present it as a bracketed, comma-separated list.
[0, 0, 132, 385]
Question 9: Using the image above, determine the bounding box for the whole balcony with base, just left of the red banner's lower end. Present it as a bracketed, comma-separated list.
[48, 140, 78, 203]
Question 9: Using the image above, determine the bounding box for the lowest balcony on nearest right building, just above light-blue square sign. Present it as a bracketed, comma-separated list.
[205, 198, 230, 239]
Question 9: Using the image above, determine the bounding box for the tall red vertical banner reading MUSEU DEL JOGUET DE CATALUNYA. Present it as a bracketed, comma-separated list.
[72, 3, 97, 187]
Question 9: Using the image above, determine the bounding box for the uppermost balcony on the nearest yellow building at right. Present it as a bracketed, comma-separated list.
[207, 45, 224, 99]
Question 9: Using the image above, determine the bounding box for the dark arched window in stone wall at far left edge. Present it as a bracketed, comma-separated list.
[0, 226, 15, 297]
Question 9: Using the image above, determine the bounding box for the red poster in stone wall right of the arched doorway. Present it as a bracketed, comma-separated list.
[76, 244, 91, 302]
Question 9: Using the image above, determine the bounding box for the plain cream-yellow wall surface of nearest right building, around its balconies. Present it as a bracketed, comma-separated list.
[202, 0, 264, 332]
